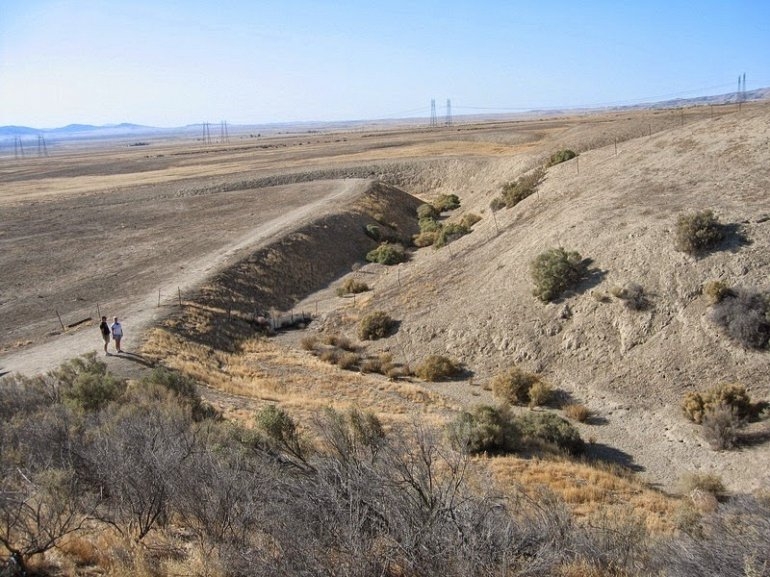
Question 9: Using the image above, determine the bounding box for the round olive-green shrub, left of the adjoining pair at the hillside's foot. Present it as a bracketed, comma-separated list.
[448, 405, 518, 454]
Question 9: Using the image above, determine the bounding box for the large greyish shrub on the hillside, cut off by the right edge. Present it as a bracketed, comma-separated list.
[710, 289, 770, 349]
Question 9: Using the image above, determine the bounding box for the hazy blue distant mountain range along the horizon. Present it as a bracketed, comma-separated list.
[0, 88, 770, 139]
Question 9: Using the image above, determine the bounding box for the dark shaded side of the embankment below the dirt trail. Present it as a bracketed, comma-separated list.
[160, 182, 421, 350]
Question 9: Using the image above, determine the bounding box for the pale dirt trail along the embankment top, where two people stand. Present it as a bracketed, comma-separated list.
[0, 179, 371, 377]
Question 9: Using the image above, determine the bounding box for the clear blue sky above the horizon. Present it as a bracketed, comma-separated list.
[0, 0, 770, 128]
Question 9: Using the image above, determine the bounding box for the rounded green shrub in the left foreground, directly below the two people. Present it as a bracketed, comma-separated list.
[52, 353, 126, 411]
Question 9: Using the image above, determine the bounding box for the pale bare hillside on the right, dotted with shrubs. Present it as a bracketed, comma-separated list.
[320, 102, 770, 490]
